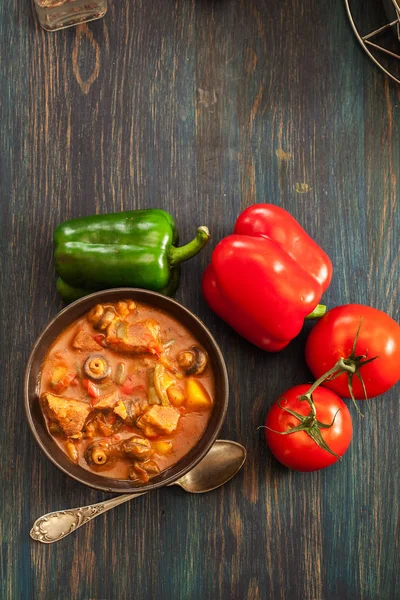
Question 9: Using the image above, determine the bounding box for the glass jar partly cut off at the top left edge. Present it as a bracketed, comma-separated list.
[34, 0, 107, 31]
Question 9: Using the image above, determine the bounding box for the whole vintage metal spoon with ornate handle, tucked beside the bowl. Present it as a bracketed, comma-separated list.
[30, 440, 246, 544]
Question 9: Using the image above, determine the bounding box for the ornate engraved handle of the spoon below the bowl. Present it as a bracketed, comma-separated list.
[30, 492, 147, 544]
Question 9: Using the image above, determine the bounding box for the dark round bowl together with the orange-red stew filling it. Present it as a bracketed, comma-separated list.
[24, 288, 229, 493]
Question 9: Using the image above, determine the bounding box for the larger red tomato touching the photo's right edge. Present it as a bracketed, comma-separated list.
[305, 304, 400, 399]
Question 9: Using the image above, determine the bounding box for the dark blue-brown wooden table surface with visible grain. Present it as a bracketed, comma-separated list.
[0, 0, 400, 600]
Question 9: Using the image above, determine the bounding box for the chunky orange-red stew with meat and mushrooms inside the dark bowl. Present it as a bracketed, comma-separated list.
[40, 300, 215, 485]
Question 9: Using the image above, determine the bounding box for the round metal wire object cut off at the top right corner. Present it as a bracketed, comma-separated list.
[345, 0, 400, 84]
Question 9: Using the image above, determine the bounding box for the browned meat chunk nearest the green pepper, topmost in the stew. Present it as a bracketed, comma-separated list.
[106, 319, 162, 354]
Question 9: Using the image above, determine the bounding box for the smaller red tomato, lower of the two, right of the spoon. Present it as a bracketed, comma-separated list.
[265, 384, 353, 471]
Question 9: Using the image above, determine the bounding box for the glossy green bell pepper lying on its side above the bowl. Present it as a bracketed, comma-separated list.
[54, 209, 210, 302]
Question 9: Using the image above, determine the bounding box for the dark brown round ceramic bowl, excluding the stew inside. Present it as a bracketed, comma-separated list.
[24, 288, 228, 493]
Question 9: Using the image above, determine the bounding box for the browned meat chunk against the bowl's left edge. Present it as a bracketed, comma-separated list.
[42, 394, 91, 437]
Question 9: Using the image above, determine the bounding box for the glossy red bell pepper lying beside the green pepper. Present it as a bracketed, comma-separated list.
[202, 204, 332, 352]
